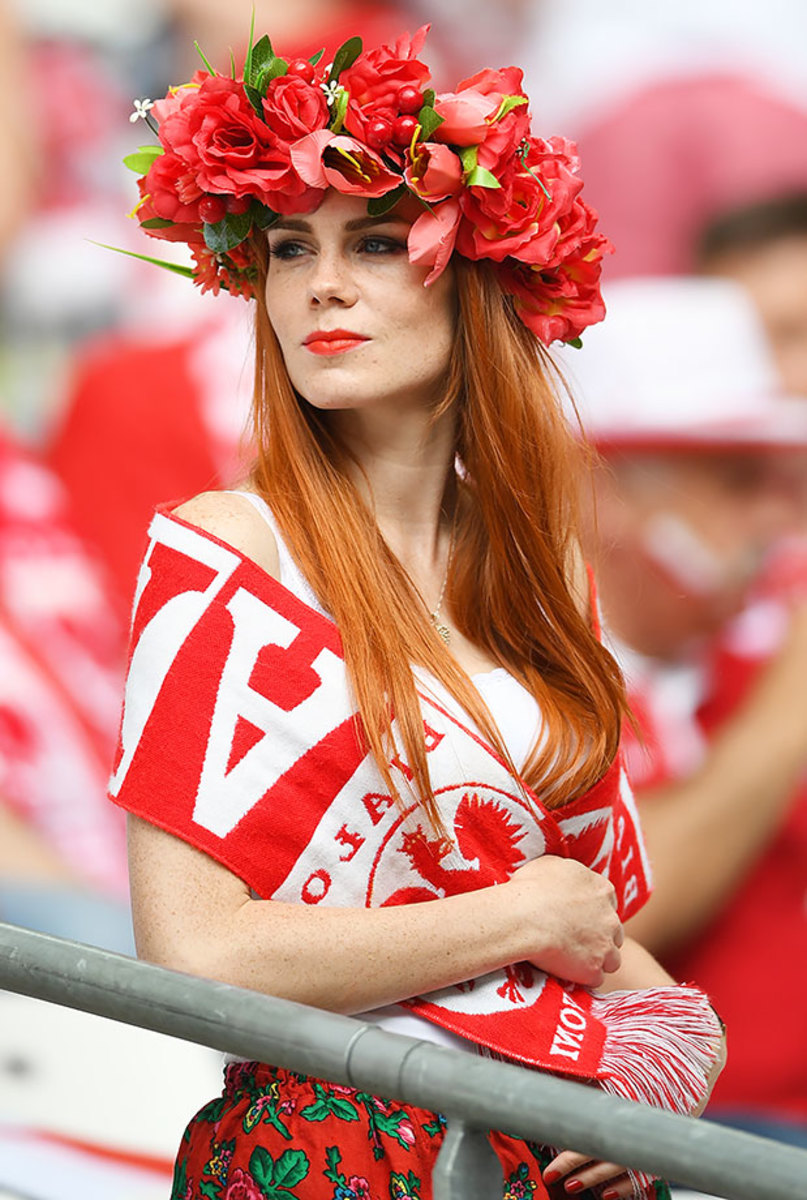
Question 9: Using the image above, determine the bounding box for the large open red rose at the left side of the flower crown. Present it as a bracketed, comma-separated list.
[160, 76, 319, 214]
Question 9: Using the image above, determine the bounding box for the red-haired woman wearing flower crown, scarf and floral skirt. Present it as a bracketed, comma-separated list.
[112, 31, 721, 1200]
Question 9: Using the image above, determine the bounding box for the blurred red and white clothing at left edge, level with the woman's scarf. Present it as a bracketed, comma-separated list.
[0, 432, 127, 896]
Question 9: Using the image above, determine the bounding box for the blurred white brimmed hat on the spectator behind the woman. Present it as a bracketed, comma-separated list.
[552, 276, 807, 451]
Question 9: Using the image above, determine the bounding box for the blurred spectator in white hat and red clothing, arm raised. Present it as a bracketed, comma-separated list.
[562, 278, 807, 1144]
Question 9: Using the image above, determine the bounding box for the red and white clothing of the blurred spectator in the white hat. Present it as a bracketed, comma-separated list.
[615, 580, 807, 1124]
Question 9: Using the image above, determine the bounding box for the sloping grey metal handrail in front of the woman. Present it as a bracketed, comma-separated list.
[0, 924, 807, 1200]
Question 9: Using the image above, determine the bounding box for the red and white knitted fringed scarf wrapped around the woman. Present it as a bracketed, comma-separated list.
[110, 514, 719, 1166]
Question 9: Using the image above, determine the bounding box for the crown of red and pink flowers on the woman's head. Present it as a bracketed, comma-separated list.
[124, 25, 611, 344]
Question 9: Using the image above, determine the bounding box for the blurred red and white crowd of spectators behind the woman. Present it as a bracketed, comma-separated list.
[0, 0, 807, 1180]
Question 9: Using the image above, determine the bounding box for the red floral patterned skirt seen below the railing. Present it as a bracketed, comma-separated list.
[171, 1062, 660, 1200]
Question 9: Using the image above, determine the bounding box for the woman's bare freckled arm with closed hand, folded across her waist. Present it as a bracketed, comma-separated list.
[130, 817, 621, 1013]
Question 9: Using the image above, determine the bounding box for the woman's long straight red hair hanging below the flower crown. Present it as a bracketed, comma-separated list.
[252, 244, 624, 827]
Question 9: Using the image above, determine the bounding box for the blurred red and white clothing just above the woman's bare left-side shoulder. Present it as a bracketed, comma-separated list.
[48, 304, 253, 607]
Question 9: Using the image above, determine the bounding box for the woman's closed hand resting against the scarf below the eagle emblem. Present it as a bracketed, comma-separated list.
[502, 854, 624, 988]
